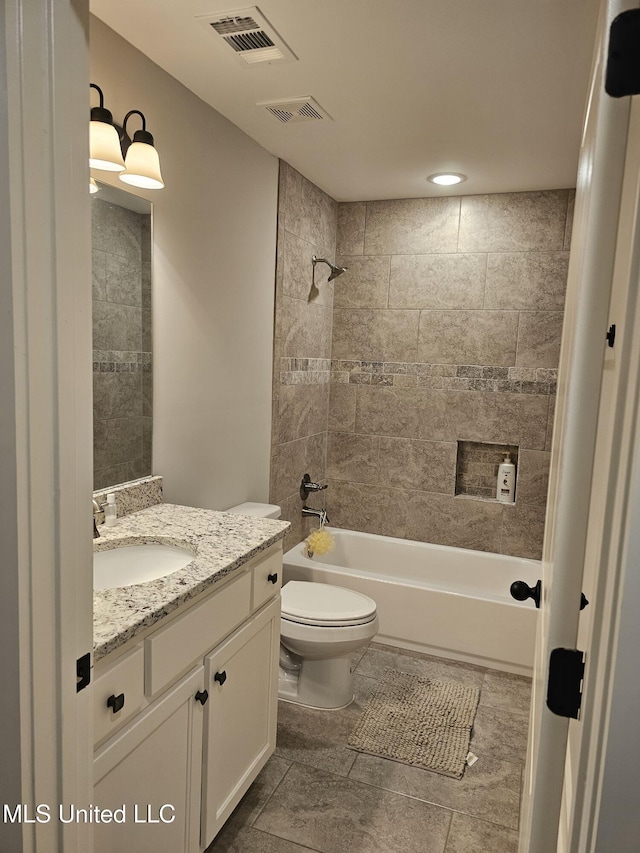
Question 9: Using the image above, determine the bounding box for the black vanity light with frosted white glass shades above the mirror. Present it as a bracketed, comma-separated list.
[89, 83, 164, 192]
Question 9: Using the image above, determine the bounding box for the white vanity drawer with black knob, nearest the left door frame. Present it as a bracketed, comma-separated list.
[93, 645, 145, 743]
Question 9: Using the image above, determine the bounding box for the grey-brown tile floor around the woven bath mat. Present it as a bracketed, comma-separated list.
[207, 643, 530, 853]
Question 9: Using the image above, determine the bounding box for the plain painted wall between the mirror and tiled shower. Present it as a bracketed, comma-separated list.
[91, 18, 278, 509]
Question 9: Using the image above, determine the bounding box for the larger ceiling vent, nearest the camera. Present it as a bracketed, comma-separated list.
[198, 6, 298, 65]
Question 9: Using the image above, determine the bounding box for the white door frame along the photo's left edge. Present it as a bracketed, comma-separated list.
[0, 0, 93, 853]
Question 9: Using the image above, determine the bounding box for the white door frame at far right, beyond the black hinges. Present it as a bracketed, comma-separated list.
[561, 97, 640, 853]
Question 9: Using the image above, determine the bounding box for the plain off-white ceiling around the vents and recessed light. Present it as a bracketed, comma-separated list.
[90, 0, 599, 201]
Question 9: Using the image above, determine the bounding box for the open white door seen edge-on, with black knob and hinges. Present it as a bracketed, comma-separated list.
[520, 0, 632, 853]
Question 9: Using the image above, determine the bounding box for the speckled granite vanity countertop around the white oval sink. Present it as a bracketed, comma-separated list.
[93, 503, 289, 663]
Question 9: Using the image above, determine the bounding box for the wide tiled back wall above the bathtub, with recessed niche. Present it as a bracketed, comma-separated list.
[328, 190, 573, 558]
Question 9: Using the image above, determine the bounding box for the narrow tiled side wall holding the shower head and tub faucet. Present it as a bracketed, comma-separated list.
[269, 161, 337, 549]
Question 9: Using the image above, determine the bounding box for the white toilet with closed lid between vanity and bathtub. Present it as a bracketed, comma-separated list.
[226, 503, 378, 710]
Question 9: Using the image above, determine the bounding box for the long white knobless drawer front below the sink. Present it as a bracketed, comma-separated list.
[144, 572, 251, 696]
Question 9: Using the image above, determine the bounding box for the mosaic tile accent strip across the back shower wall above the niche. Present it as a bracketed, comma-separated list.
[331, 359, 558, 395]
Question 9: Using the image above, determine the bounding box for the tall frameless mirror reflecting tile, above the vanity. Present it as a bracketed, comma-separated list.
[91, 183, 152, 489]
